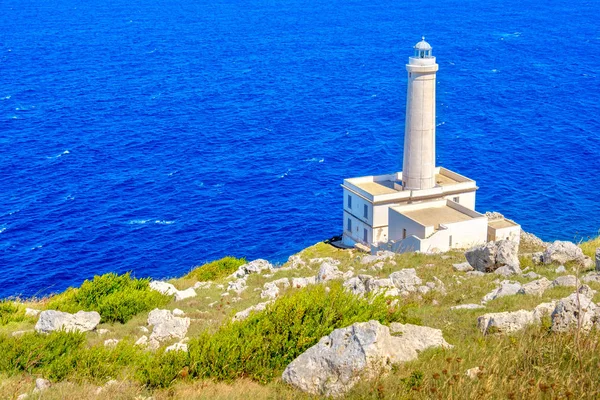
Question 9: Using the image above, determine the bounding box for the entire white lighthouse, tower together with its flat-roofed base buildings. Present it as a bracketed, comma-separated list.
[342, 39, 520, 252]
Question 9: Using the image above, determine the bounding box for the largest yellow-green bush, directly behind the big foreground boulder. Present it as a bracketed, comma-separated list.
[189, 283, 414, 382]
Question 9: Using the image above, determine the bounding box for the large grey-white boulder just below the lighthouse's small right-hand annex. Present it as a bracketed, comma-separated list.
[465, 240, 520, 272]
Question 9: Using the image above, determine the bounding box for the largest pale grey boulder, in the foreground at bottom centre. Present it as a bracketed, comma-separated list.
[282, 321, 447, 396]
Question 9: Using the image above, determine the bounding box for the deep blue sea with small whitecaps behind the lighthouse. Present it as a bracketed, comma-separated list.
[0, 0, 600, 297]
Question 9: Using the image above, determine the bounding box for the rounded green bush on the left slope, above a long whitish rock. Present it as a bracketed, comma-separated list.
[48, 273, 170, 323]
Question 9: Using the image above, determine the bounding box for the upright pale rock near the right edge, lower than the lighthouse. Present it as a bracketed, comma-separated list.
[552, 285, 597, 332]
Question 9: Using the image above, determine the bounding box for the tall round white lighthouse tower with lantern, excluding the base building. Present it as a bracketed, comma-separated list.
[402, 38, 438, 190]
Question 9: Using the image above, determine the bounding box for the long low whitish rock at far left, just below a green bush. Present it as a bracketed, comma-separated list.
[35, 310, 100, 333]
